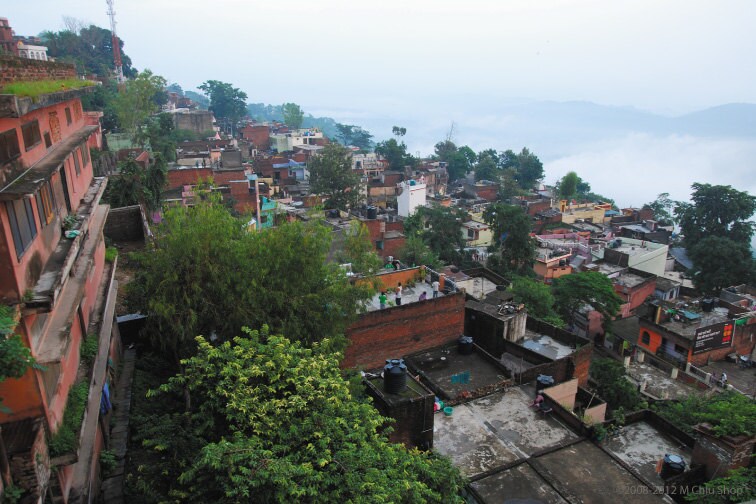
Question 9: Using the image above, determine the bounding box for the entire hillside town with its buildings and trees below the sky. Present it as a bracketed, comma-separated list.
[0, 10, 756, 504]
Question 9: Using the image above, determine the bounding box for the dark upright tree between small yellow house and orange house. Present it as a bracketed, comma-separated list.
[483, 203, 535, 276]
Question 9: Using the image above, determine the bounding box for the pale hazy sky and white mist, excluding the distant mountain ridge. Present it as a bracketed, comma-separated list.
[5, 0, 756, 212]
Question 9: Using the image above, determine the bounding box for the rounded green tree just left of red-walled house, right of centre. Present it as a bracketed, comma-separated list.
[553, 271, 622, 328]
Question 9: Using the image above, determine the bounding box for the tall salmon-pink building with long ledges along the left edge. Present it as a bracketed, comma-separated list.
[0, 60, 119, 502]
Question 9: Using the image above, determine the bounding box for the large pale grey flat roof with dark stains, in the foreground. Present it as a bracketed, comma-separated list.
[433, 387, 577, 477]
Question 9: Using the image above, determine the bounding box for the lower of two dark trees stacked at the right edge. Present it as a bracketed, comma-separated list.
[688, 236, 756, 296]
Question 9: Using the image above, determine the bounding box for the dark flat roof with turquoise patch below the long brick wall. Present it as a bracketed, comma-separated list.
[407, 345, 508, 398]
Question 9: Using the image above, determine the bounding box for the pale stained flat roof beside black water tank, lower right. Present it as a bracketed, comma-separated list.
[603, 422, 690, 486]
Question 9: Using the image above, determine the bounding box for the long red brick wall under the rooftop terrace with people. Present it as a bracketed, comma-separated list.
[341, 292, 465, 369]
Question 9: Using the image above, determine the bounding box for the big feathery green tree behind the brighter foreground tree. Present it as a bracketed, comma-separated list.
[127, 197, 371, 363]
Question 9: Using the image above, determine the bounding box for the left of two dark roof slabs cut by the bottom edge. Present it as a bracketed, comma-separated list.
[470, 463, 567, 504]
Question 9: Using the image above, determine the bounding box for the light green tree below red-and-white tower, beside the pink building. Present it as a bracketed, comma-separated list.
[113, 70, 165, 144]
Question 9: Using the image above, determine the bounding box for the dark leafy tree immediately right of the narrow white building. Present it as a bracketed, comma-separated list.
[404, 204, 465, 265]
